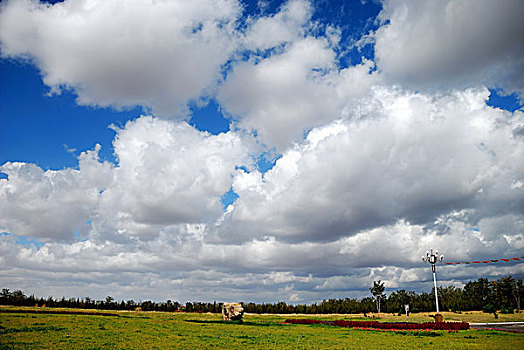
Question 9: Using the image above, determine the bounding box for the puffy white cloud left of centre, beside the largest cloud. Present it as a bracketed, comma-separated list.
[96, 117, 250, 237]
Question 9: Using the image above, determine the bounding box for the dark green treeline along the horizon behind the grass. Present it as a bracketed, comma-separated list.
[0, 276, 524, 314]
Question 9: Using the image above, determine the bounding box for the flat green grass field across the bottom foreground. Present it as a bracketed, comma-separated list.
[0, 308, 524, 349]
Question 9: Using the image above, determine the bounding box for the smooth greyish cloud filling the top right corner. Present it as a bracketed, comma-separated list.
[375, 0, 524, 97]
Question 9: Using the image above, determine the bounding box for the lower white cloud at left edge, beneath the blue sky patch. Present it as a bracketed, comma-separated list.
[0, 145, 113, 240]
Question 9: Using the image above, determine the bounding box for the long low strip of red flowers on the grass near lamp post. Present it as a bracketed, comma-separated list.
[285, 319, 469, 331]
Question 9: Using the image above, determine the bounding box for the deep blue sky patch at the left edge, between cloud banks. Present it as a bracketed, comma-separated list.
[0, 59, 141, 170]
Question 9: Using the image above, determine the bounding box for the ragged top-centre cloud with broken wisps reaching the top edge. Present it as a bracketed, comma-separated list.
[218, 1, 380, 152]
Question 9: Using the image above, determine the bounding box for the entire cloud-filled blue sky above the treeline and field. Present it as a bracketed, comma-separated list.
[0, 0, 524, 302]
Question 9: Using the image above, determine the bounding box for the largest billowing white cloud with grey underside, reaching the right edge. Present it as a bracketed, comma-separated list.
[218, 89, 524, 241]
